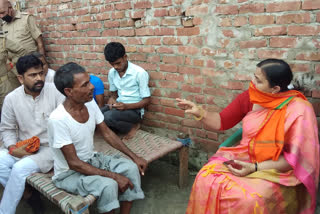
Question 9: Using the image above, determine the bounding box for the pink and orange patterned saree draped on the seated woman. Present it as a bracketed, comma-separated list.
[186, 98, 319, 214]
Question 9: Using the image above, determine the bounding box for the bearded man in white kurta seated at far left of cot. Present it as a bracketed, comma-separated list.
[0, 55, 65, 214]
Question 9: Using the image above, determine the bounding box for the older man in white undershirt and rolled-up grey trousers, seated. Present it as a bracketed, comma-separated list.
[48, 63, 147, 214]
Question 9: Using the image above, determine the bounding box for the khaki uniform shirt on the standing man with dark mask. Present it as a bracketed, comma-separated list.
[2, 11, 42, 58]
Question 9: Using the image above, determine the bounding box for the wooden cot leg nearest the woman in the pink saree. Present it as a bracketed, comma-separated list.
[179, 146, 189, 188]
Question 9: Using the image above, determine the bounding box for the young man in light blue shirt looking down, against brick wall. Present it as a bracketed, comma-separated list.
[102, 42, 151, 139]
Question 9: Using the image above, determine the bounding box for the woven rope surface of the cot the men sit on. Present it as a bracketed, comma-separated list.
[27, 130, 187, 214]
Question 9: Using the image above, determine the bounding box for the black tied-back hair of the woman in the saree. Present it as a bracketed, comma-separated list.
[257, 59, 293, 92]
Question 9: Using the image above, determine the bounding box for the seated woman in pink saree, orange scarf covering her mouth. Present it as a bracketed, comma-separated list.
[177, 59, 319, 214]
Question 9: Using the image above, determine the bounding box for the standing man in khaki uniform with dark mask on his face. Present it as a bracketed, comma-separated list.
[0, 0, 46, 73]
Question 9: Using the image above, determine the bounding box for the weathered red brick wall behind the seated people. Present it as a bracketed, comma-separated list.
[19, 0, 320, 167]
